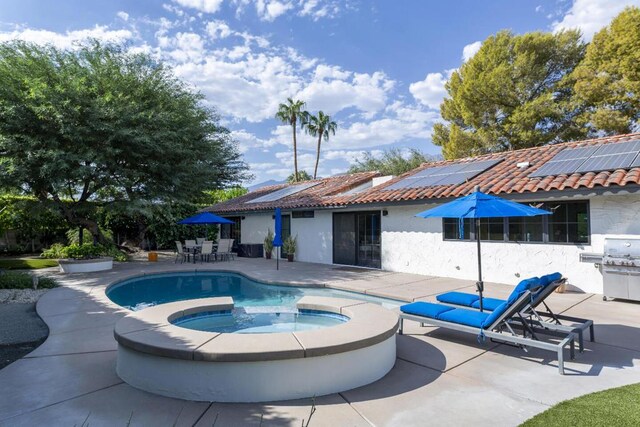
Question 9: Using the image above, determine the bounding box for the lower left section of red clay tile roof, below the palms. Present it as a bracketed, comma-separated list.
[203, 172, 380, 214]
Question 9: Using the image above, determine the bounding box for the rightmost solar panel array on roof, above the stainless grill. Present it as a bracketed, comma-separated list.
[529, 140, 640, 177]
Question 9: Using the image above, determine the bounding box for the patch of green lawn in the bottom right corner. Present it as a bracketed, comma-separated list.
[522, 383, 640, 427]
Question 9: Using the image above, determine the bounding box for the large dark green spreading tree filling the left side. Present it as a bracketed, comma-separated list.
[0, 41, 246, 246]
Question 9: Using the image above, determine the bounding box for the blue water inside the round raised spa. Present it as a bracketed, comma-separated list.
[173, 309, 349, 334]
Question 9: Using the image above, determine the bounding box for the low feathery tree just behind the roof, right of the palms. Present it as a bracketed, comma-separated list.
[349, 148, 436, 175]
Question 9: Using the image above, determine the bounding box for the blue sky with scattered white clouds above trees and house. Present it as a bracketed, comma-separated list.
[0, 0, 640, 183]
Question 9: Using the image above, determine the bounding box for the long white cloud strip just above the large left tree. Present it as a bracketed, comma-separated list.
[0, 25, 134, 49]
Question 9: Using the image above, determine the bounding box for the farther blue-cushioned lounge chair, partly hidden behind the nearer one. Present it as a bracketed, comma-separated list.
[436, 273, 595, 353]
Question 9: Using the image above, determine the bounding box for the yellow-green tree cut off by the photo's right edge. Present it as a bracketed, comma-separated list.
[572, 7, 640, 134]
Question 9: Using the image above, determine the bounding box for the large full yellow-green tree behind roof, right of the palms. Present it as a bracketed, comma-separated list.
[433, 31, 585, 159]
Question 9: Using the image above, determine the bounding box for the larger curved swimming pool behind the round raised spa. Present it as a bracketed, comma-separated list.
[107, 272, 403, 313]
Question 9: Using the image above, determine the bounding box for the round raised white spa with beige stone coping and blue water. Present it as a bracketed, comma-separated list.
[115, 296, 398, 402]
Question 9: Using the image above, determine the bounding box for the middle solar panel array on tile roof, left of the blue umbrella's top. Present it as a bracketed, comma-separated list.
[386, 159, 502, 190]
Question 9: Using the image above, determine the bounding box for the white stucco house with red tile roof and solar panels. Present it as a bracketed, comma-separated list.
[206, 134, 640, 293]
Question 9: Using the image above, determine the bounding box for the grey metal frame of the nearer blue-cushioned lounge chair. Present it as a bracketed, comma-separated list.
[398, 291, 576, 375]
